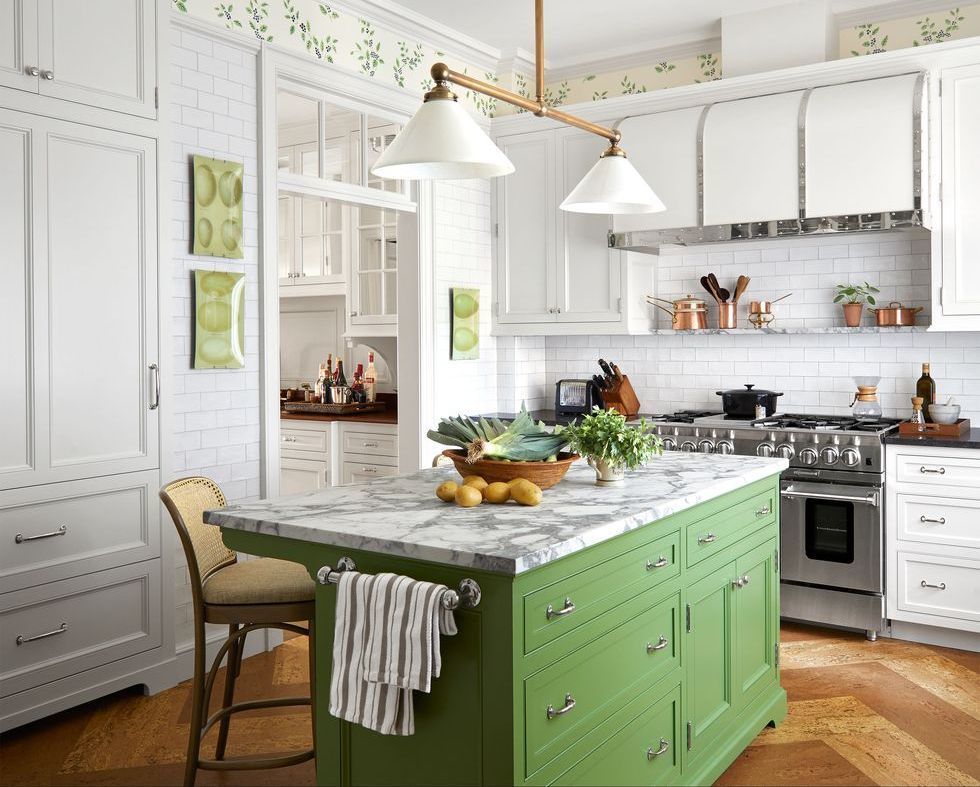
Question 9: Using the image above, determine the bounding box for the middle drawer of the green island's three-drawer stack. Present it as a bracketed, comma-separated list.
[524, 594, 680, 775]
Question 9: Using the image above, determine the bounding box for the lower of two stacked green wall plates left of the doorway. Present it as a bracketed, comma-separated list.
[194, 271, 245, 369]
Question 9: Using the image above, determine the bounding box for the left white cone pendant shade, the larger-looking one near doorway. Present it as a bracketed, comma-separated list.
[371, 99, 514, 180]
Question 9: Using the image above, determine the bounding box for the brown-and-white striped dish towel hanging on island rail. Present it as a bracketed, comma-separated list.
[330, 571, 456, 735]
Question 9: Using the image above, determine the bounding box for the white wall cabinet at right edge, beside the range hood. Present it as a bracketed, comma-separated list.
[933, 65, 980, 330]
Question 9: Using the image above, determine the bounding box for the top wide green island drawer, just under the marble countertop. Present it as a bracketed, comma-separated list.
[524, 530, 680, 653]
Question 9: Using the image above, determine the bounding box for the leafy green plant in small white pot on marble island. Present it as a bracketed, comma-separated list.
[561, 407, 664, 486]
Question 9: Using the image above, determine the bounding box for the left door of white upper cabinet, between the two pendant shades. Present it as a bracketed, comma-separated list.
[497, 131, 557, 323]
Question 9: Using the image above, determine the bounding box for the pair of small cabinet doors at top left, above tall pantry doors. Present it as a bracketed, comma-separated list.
[0, 0, 157, 118]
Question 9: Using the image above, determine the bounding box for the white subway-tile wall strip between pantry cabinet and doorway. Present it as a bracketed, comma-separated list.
[166, 26, 259, 649]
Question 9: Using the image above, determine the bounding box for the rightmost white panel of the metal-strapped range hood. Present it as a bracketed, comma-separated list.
[800, 74, 922, 218]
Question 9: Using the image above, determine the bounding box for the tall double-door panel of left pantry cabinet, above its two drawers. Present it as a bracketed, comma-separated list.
[0, 110, 159, 489]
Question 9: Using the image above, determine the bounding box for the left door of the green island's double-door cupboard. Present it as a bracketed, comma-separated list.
[684, 562, 736, 757]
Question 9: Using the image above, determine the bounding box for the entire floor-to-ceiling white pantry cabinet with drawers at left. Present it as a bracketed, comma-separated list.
[0, 0, 174, 730]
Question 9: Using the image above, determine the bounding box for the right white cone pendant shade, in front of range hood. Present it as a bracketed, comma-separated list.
[561, 153, 666, 214]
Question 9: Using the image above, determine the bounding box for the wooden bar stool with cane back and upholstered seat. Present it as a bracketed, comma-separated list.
[160, 476, 316, 787]
